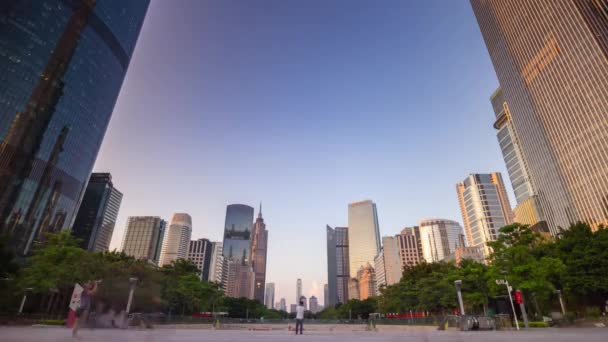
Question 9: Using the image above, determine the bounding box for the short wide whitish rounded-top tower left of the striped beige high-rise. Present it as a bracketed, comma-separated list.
[418, 219, 462, 263]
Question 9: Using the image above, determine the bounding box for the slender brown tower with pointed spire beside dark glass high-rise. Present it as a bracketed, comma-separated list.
[251, 203, 274, 304]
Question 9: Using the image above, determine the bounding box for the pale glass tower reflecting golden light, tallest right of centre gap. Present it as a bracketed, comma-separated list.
[348, 200, 380, 278]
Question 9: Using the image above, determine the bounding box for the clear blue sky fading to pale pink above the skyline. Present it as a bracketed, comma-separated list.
[95, 0, 510, 304]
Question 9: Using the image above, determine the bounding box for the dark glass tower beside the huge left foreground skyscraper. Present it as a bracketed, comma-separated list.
[72, 173, 122, 252]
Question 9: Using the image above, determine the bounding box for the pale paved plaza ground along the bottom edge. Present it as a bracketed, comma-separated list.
[0, 327, 608, 342]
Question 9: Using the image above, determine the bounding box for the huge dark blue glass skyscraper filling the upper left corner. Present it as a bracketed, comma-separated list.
[0, 0, 149, 255]
